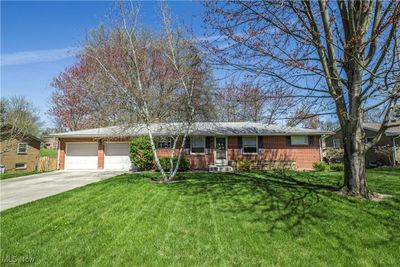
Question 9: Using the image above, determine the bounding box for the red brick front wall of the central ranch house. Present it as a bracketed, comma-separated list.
[59, 136, 321, 170]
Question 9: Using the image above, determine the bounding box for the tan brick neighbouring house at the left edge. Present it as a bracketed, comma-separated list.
[0, 130, 43, 172]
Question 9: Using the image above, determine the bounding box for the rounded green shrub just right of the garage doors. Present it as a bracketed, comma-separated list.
[129, 136, 154, 171]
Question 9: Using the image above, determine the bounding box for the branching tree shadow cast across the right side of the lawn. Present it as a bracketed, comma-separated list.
[114, 172, 400, 252]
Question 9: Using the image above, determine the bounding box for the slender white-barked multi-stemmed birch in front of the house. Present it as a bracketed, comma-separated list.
[83, 2, 209, 182]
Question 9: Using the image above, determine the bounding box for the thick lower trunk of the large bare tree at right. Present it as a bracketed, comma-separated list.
[342, 123, 368, 198]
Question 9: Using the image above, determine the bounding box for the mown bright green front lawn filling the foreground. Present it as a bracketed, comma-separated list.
[1, 169, 400, 266]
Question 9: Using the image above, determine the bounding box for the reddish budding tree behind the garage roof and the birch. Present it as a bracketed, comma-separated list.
[48, 28, 214, 131]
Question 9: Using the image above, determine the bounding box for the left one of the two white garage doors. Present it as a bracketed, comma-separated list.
[65, 143, 98, 170]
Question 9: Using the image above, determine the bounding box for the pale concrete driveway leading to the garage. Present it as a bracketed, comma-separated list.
[0, 171, 124, 211]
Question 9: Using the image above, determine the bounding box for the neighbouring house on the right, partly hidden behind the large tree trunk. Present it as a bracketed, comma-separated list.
[325, 123, 400, 167]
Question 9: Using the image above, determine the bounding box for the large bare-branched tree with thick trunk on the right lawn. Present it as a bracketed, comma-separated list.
[205, 0, 400, 198]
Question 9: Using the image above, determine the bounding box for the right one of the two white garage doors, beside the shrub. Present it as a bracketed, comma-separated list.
[104, 143, 131, 170]
